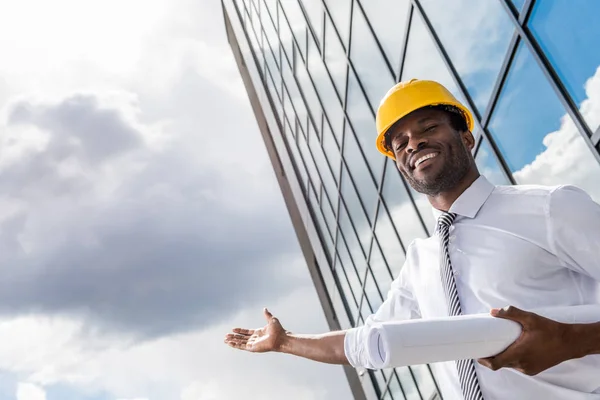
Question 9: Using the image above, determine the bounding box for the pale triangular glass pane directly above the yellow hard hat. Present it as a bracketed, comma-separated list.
[402, 7, 474, 126]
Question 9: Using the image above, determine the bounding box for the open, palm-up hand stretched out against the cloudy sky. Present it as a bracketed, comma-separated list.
[225, 308, 287, 353]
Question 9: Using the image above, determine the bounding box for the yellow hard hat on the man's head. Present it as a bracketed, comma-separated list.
[375, 79, 473, 160]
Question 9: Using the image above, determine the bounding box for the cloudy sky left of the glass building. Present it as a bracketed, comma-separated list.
[0, 0, 350, 400]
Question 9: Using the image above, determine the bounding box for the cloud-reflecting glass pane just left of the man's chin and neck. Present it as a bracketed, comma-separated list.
[382, 159, 433, 243]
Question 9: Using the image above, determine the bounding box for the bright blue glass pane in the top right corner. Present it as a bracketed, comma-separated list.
[529, 0, 600, 132]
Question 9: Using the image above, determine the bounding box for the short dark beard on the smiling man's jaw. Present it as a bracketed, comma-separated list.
[400, 140, 471, 196]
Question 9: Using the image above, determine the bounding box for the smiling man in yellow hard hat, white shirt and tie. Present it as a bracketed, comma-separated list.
[225, 79, 600, 400]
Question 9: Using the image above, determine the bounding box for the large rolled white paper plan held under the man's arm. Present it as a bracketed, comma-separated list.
[366, 305, 600, 369]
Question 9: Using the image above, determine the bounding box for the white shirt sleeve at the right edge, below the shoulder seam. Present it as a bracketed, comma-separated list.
[548, 186, 600, 281]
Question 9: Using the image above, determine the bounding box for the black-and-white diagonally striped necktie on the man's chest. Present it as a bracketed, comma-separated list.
[437, 213, 483, 400]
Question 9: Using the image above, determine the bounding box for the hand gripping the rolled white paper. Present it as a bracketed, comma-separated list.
[478, 306, 582, 375]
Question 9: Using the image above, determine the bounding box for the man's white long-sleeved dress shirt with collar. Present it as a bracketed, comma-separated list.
[344, 176, 600, 400]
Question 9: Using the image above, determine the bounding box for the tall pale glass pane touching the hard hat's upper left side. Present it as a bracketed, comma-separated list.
[350, 7, 394, 109]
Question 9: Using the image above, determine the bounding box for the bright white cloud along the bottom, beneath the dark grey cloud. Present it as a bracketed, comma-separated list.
[0, 284, 349, 400]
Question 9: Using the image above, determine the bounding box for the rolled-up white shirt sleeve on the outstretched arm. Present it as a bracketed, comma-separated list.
[344, 247, 421, 369]
